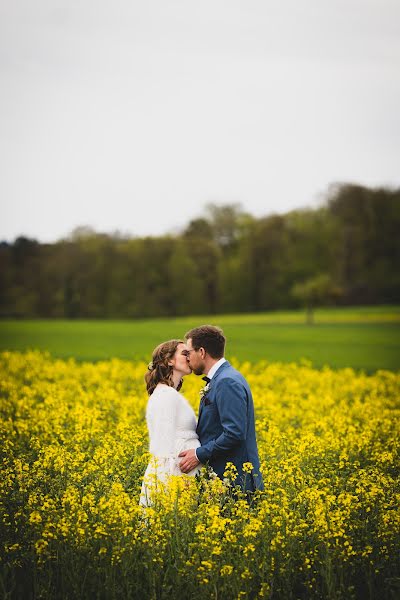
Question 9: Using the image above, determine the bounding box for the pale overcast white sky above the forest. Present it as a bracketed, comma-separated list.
[0, 0, 400, 241]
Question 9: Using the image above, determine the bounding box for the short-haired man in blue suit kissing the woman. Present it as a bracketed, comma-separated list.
[179, 325, 264, 492]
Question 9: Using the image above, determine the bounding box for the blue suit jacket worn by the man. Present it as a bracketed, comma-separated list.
[196, 361, 264, 491]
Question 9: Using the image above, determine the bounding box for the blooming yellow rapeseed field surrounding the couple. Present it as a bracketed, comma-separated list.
[0, 352, 400, 600]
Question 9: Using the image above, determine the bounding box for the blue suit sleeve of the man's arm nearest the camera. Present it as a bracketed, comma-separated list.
[196, 378, 247, 464]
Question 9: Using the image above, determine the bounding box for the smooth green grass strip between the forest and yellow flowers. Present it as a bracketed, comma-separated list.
[0, 306, 400, 372]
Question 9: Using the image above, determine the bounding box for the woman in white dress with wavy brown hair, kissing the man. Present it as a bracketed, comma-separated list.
[139, 340, 201, 506]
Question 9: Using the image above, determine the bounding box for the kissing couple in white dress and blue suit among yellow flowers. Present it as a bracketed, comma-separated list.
[139, 325, 263, 506]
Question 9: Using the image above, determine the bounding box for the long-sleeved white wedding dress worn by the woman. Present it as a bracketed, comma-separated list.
[139, 383, 201, 506]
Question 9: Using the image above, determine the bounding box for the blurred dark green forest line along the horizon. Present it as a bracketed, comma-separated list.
[0, 184, 400, 318]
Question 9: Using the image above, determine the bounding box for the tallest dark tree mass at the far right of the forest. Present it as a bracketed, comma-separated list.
[328, 184, 400, 304]
